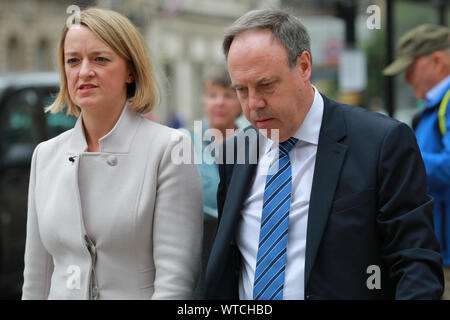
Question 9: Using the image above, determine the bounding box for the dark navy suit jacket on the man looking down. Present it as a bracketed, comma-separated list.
[205, 97, 444, 299]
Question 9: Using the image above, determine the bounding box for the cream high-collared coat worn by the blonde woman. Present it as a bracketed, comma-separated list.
[23, 107, 202, 299]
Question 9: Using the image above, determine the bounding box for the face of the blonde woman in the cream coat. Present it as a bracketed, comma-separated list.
[64, 26, 133, 111]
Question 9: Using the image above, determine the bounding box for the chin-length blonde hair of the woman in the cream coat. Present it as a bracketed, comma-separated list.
[46, 8, 160, 116]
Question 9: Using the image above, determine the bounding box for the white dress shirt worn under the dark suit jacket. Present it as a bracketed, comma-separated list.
[236, 87, 323, 300]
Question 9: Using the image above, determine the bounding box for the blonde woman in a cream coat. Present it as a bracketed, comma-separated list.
[23, 9, 202, 299]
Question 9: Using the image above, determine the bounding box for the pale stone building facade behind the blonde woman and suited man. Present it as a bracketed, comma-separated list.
[0, 0, 280, 125]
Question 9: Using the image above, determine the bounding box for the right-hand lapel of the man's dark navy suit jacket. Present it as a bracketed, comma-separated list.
[305, 97, 347, 288]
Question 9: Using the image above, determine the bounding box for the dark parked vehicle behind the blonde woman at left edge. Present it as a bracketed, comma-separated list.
[0, 72, 76, 299]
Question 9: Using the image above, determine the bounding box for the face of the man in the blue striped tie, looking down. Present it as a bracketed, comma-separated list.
[228, 29, 314, 142]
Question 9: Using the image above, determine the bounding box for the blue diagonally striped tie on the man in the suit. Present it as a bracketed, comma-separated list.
[253, 138, 298, 300]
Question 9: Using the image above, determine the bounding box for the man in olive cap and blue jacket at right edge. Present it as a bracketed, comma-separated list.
[383, 25, 450, 299]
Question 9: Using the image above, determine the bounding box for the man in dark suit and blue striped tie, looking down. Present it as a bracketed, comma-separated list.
[205, 9, 443, 299]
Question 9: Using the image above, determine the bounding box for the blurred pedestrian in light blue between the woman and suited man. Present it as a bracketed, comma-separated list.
[192, 68, 242, 298]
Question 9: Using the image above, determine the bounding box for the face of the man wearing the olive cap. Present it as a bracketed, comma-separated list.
[405, 54, 439, 99]
